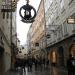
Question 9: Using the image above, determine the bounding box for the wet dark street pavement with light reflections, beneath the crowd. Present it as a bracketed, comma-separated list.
[5, 67, 67, 75]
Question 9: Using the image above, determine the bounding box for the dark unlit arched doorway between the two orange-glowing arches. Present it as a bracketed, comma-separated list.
[58, 46, 64, 66]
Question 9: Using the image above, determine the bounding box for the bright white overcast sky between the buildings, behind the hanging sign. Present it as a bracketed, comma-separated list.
[17, 0, 41, 45]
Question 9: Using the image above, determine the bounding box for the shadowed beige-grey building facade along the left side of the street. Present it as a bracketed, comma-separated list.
[0, 0, 17, 72]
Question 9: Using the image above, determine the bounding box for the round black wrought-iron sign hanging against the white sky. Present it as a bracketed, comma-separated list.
[19, 0, 36, 23]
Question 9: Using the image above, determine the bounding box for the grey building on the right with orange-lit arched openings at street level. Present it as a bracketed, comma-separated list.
[44, 0, 75, 66]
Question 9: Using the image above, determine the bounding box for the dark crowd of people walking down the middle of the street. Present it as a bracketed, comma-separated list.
[14, 57, 49, 71]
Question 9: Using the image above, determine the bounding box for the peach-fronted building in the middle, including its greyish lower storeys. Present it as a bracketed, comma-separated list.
[31, 0, 45, 57]
